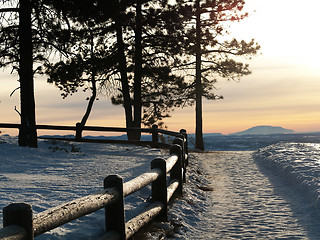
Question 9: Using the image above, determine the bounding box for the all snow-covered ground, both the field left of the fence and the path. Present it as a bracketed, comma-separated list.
[0, 136, 320, 240]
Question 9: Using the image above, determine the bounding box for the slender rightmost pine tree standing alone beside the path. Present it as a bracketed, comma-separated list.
[177, 0, 260, 150]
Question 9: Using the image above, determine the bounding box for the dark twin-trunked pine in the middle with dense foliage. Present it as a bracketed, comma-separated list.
[49, 0, 192, 139]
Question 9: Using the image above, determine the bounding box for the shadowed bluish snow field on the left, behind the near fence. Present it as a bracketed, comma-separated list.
[0, 136, 167, 239]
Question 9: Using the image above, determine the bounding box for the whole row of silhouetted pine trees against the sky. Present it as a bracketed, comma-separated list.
[0, 0, 260, 149]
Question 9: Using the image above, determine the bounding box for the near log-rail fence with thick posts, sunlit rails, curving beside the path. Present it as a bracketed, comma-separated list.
[0, 134, 188, 240]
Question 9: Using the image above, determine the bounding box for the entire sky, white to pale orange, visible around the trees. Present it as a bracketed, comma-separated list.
[0, 0, 320, 135]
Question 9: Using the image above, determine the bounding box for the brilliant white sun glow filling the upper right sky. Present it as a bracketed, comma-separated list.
[230, 0, 320, 68]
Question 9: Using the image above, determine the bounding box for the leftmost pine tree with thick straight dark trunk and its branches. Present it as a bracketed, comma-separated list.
[0, 0, 72, 147]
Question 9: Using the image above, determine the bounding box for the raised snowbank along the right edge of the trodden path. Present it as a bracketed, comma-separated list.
[254, 143, 320, 210]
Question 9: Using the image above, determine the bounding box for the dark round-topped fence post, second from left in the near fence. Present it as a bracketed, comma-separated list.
[104, 175, 126, 240]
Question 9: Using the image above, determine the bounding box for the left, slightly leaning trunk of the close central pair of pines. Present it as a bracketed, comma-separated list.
[115, 1, 134, 140]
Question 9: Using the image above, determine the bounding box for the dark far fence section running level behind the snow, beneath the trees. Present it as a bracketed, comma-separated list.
[0, 123, 186, 147]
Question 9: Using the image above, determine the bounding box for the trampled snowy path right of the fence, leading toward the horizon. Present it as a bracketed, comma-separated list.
[171, 152, 320, 239]
